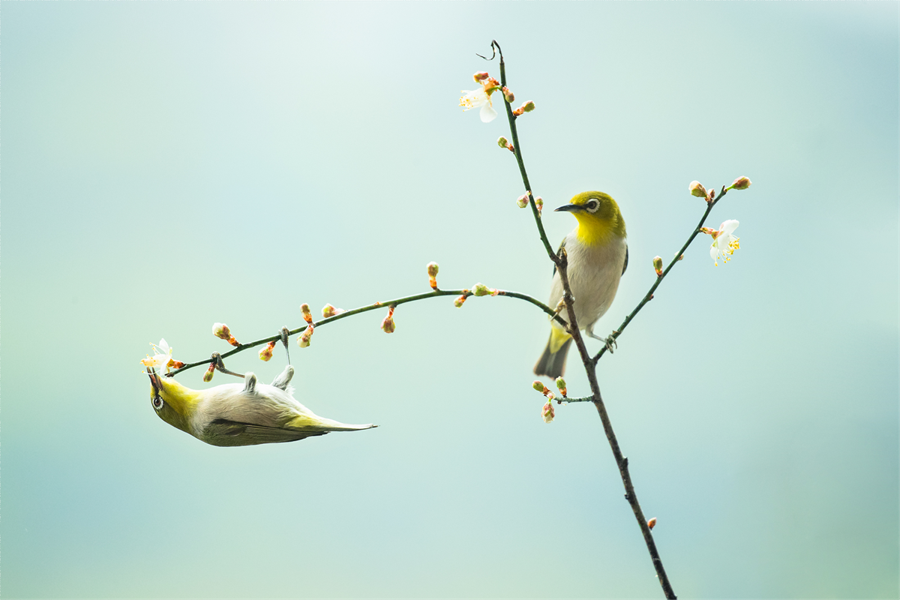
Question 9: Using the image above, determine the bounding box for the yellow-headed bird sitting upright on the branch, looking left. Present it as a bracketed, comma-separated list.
[534, 192, 628, 379]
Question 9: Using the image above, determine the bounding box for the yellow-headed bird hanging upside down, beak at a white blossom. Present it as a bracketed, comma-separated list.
[148, 365, 376, 446]
